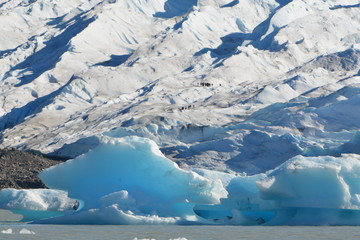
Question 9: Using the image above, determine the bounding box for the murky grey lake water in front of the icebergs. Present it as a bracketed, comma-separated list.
[0, 211, 360, 240]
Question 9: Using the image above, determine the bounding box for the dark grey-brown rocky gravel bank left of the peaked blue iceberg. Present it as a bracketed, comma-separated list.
[0, 149, 61, 189]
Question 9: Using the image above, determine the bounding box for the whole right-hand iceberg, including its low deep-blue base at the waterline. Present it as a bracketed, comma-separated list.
[194, 154, 360, 225]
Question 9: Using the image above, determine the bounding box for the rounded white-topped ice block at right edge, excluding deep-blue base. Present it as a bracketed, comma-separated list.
[257, 155, 360, 209]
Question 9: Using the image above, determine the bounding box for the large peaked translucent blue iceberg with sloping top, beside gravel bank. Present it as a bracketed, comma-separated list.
[40, 137, 227, 224]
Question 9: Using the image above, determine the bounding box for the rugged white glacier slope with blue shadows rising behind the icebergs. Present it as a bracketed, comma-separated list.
[0, 0, 360, 174]
